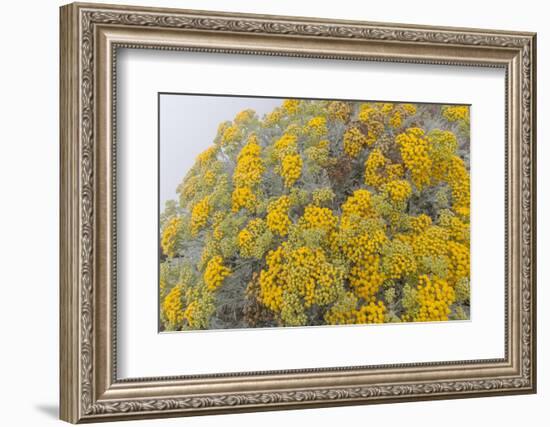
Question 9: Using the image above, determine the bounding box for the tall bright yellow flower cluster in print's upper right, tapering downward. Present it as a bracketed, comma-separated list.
[395, 128, 432, 189]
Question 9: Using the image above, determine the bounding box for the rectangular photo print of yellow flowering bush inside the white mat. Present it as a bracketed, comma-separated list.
[159, 93, 470, 331]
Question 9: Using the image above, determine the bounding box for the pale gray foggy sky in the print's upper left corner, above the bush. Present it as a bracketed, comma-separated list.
[159, 94, 282, 211]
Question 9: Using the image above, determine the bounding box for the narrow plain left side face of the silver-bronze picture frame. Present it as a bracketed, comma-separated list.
[59, 4, 80, 423]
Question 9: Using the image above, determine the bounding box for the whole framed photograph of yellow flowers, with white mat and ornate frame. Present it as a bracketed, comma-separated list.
[60, 3, 536, 423]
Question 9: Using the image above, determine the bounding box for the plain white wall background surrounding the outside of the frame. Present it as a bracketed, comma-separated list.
[0, 0, 550, 427]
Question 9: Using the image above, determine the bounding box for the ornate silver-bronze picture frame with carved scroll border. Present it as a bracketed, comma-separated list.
[60, 4, 536, 423]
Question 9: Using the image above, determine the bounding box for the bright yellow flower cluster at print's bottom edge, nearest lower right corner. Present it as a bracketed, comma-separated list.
[414, 275, 455, 322]
